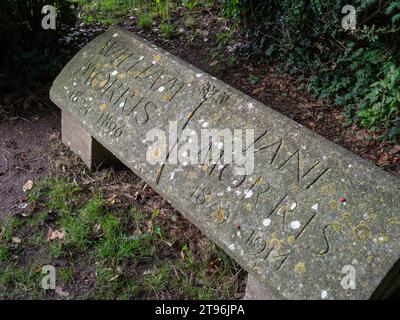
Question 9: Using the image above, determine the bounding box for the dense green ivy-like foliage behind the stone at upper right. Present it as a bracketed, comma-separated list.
[228, 0, 400, 139]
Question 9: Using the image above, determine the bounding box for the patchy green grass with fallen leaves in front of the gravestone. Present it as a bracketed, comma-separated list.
[0, 178, 243, 300]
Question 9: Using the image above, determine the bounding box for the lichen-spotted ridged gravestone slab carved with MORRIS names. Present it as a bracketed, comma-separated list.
[51, 28, 400, 299]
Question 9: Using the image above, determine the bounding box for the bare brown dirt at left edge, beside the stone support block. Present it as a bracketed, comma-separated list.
[0, 96, 61, 220]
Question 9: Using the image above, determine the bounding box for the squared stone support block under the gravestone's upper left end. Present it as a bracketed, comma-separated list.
[61, 110, 119, 170]
